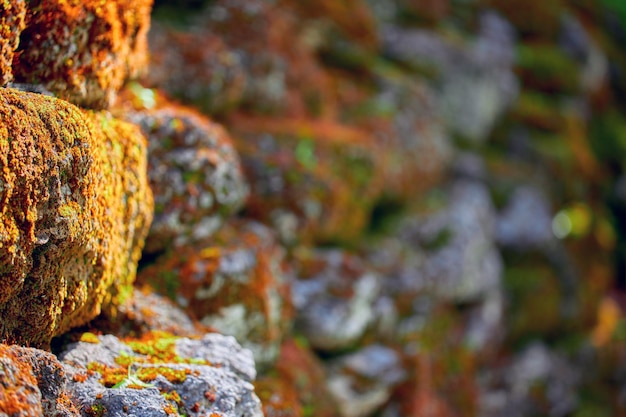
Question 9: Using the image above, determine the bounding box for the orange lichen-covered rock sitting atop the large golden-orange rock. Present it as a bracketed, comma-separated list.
[13, 0, 152, 108]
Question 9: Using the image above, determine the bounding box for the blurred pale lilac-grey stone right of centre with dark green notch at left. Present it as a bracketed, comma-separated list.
[394, 180, 502, 302]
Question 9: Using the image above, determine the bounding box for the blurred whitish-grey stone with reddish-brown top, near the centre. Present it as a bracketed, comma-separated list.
[292, 250, 382, 350]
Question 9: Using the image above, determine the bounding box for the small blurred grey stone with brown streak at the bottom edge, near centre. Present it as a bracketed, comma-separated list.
[327, 345, 406, 417]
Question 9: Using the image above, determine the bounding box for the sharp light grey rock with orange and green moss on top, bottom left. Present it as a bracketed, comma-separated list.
[61, 334, 263, 417]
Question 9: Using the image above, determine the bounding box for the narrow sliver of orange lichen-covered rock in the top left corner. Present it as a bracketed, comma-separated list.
[0, 0, 26, 86]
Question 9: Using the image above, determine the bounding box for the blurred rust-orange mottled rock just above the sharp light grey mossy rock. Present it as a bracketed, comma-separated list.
[138, 221, 291, 365]
